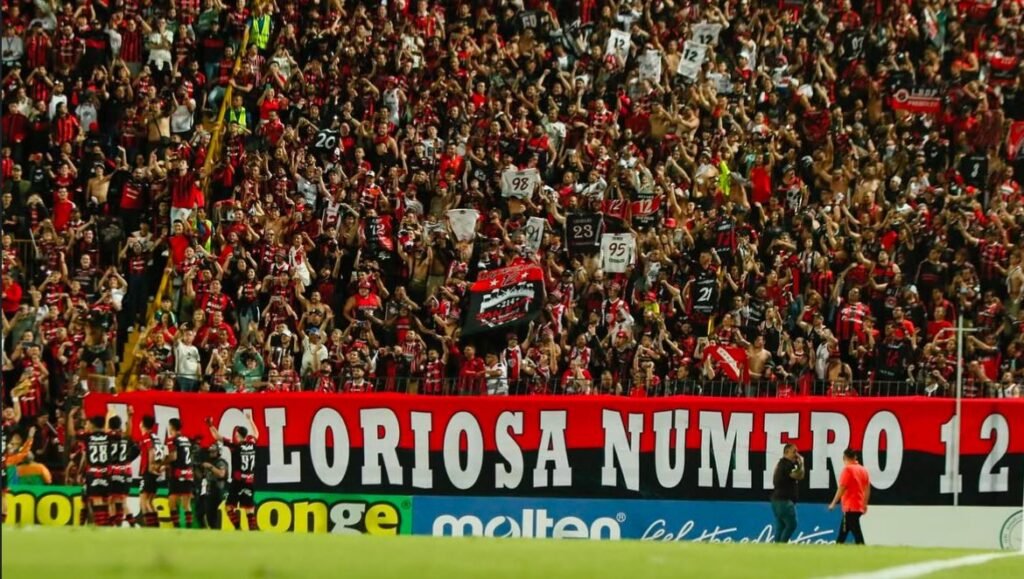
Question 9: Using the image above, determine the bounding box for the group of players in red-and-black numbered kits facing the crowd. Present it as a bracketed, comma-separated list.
[3, 407, 259, 531]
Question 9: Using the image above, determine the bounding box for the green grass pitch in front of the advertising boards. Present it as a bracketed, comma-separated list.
[2, 527, 1024, 579]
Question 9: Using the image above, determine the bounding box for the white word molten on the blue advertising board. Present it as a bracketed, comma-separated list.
[431, 508, 625, 540]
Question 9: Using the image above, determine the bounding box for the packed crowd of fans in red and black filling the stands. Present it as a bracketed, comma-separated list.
[0, 0, 1024, 469]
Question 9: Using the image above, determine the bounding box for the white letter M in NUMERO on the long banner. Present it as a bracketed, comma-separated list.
[697, 411, 754, 489]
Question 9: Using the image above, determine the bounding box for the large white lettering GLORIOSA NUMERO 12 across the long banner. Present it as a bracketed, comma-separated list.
[136, 405, 999, 493]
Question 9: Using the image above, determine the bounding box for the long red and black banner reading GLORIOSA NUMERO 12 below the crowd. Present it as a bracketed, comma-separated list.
[85, 392, 1024, 505]
